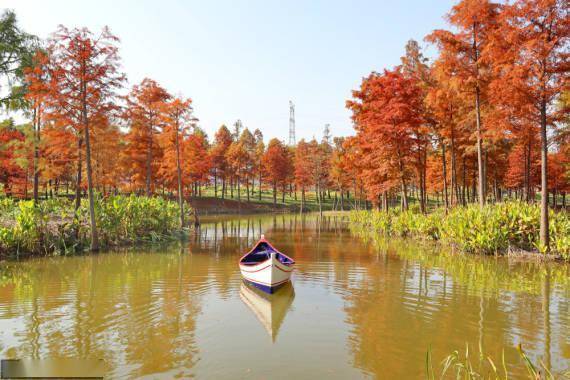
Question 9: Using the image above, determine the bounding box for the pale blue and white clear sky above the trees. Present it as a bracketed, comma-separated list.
[0, 0, 453, 142]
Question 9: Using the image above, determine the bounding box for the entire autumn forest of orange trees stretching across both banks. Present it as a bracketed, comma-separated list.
[0, 0, 570, 257]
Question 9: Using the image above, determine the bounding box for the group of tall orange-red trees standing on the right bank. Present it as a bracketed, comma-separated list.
[346, 0, 570, 247]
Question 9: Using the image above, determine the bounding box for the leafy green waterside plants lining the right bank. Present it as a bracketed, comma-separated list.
[350, 201, 570, 260]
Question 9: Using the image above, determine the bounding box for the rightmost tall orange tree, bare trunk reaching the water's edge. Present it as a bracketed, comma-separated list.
[494, 0, 570, 250]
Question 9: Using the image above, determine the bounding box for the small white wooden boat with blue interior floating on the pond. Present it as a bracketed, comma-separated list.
[239, 235, 295, 294]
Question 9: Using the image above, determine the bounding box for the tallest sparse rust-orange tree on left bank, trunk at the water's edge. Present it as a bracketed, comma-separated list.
[49, 26, 125, 251]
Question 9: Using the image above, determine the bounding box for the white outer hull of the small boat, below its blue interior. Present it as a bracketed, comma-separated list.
[239, 254, 293, 293]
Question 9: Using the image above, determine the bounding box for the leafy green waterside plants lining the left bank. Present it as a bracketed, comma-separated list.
[0, 196, 188, 258]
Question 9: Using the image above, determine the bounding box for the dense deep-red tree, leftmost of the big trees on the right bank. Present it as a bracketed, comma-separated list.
[347, 69, 423, 209]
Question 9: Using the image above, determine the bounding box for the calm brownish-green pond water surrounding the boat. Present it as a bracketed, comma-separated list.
[0, 215, 570, 379]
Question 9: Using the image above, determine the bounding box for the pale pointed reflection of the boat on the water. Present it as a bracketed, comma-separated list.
[239, 281, 295, 343]
